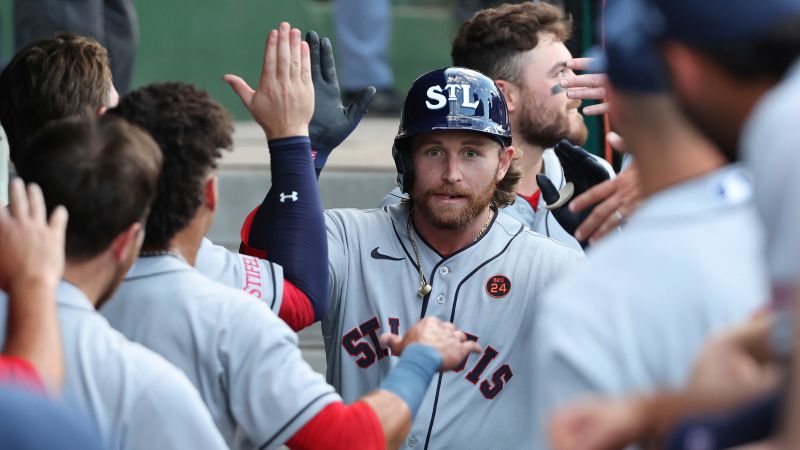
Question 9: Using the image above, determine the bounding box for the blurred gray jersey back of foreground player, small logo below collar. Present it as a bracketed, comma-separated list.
[529, 167, 768, 448]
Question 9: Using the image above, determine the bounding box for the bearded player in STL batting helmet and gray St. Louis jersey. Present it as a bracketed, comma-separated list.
[241, 68, 582, 448]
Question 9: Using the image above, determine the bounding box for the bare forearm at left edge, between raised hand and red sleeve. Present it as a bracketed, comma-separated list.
[3, 282, 64, 392]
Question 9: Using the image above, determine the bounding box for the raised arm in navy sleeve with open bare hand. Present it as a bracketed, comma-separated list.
[225, 22, 328, 322]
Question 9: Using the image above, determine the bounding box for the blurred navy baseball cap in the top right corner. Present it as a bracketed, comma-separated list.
[649, 0, 800, 46]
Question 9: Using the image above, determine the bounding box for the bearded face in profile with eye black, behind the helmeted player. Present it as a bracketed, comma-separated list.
[510, 33, 588, 148]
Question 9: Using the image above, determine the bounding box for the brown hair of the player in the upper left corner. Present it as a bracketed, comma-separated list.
[0, 33, 112, 163]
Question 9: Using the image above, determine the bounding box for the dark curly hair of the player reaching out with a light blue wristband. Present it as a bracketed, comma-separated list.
[108, 82, 233, 249]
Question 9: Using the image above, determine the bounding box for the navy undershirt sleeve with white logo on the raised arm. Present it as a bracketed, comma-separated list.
[248, 136, 329, 320]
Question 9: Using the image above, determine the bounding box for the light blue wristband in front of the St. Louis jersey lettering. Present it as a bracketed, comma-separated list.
[380, 344, 442, 418]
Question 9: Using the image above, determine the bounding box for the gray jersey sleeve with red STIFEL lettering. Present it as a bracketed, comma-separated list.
[195, 238, 283, 314]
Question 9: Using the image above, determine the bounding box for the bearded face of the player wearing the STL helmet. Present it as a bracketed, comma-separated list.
[411, 131, 510, 230]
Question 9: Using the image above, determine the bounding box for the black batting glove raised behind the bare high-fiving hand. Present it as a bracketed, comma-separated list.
[306, 31, 375, 177]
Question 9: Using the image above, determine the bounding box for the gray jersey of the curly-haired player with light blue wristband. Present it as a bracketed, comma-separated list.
[102, 255, 341, 449]
